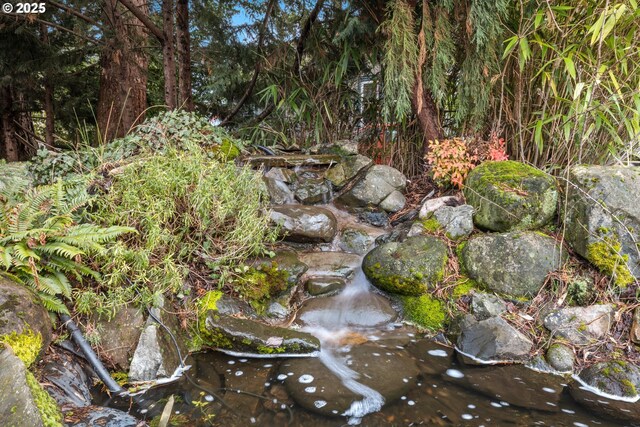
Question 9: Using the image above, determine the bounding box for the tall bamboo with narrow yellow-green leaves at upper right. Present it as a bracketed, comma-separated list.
[502, 0, 640, 165]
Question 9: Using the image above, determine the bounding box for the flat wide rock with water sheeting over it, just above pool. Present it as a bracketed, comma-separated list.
[296, 293, 398, 330]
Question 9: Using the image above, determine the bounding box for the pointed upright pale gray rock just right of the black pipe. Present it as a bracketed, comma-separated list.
[129, 301, 188, 381]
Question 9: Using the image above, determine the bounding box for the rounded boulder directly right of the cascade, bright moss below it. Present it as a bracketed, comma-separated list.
[362, 236, 448, 295]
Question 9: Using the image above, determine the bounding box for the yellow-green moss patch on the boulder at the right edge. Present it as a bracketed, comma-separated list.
[587, 236, 634, 287]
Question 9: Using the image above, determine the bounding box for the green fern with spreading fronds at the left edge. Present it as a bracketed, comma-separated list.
[0, 181, 133, 313]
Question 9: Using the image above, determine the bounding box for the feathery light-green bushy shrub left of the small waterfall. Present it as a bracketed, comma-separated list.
[88, 146, 277, 312]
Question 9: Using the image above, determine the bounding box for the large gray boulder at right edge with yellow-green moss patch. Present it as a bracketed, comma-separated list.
[564, 166, 640, 286]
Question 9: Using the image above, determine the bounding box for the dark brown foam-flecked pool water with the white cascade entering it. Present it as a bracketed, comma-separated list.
[105, 269, 633, 427]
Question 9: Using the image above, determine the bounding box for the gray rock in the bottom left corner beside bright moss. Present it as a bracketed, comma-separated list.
[0, 346, 43, 427]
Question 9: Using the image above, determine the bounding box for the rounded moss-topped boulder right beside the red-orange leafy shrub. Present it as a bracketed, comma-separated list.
[464, 160, 558, 231]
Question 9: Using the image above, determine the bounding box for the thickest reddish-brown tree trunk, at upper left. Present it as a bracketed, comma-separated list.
[97, 0, 149, 142]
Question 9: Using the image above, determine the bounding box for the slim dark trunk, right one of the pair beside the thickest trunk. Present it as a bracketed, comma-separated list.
[176, 0, 193, 111]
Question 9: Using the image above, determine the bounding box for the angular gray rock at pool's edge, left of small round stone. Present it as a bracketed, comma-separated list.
[458, 317, 533, 364]
